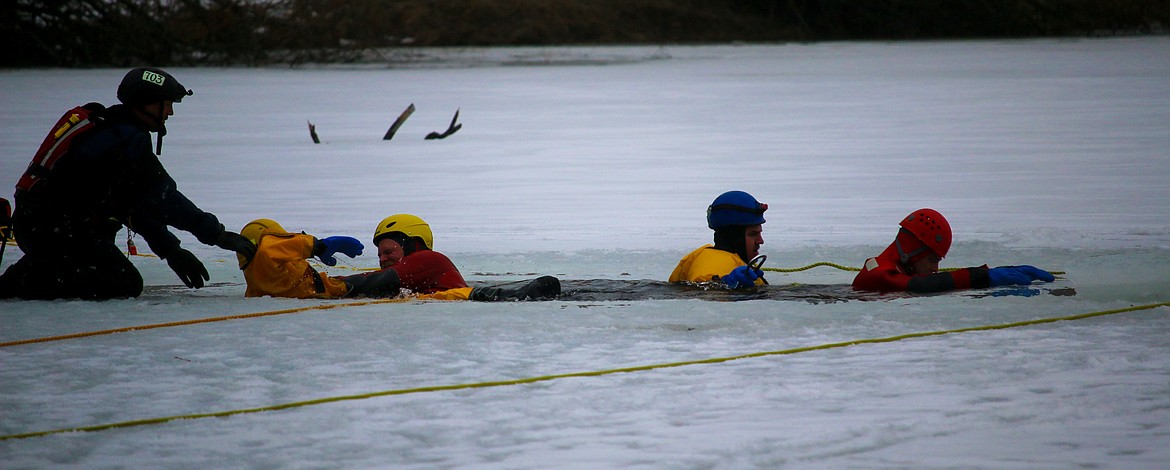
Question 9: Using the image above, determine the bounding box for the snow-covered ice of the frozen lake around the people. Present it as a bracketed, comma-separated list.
[0, 36, 1170, 469]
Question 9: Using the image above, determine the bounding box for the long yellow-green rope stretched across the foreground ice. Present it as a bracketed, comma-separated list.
[0, 302, 1170, 441]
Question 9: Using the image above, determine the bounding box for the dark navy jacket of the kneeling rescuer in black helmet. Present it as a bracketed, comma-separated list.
[13, 105, 223, 258]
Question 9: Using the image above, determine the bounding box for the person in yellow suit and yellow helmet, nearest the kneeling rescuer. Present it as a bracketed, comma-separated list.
[239, 219, 399, 298]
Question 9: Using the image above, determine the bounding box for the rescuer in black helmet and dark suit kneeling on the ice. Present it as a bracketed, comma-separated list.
[0, 68, 254, 299]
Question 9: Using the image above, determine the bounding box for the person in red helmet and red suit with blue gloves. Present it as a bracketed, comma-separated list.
[853, 208, 1055, 293]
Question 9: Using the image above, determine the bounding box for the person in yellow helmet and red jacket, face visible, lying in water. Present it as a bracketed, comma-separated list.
[351, 214, 560, 300]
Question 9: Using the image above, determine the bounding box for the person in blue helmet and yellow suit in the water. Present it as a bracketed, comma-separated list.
[669, 191, 768, 289]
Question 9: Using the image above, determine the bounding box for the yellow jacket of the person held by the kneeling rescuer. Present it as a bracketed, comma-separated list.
[243, 230, 349, 298]
